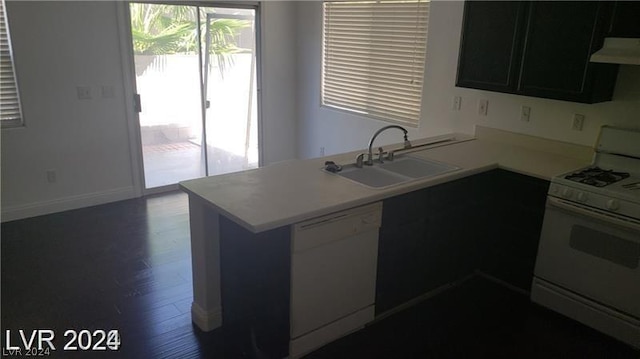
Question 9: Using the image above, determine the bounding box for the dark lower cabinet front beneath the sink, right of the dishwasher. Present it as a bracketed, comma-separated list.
[376, 172, 491, 314]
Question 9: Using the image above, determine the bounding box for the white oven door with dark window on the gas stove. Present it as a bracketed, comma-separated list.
[535, 196, 640, 318]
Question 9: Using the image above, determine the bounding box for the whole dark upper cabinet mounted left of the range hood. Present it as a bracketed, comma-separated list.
[456, 1, 618, 103]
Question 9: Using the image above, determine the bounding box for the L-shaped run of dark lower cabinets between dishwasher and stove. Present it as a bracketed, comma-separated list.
[376, 170, 549, 314]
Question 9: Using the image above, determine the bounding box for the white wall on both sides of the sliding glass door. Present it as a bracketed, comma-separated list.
[1, 1, 296, 221]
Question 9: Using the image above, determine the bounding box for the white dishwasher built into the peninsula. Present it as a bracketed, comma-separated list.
[289, 202, 382, 358]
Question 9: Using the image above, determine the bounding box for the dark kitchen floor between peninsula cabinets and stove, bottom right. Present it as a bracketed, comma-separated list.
[305, 276, 640, 359]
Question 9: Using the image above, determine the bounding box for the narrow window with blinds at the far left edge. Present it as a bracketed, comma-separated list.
[0, 0, 22, 127]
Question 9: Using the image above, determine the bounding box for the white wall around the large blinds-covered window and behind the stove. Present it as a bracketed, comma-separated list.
[298, 1, 640, 158]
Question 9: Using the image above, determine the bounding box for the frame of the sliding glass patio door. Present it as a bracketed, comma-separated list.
[116, 1, 263, 197]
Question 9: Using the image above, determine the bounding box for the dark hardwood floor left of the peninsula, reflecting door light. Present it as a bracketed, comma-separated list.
[2, 193, 221, 358]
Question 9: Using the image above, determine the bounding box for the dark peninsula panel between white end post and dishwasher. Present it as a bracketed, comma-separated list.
[219, 216, 291, 358]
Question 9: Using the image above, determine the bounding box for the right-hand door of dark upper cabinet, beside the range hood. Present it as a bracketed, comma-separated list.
[518, 1, 617, 103]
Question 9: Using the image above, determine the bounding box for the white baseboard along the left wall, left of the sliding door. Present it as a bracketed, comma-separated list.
[1, 186, 138, 222]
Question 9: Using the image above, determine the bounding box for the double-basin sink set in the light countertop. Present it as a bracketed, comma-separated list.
[337, 156, 460, 188]
